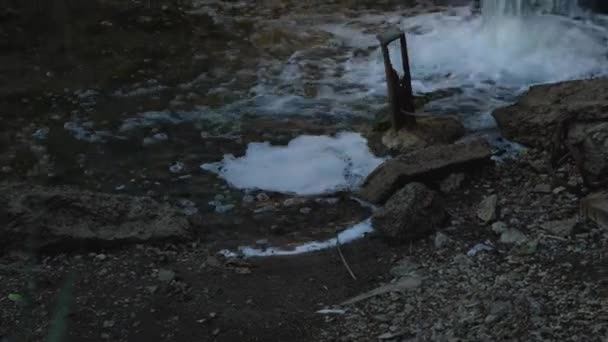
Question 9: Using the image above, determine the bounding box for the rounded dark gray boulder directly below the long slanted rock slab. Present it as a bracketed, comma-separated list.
[372, 183, 448, 242]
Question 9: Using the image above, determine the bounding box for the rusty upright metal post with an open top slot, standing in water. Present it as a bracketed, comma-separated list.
[377, 31, 416, 130]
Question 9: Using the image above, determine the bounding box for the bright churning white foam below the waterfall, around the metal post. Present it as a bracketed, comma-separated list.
[344, 8, 608, 128]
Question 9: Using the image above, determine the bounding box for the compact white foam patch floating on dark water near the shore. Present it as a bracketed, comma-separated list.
[201, 133, 382, 195]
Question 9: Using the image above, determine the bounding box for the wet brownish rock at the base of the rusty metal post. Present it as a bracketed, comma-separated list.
[382, 116, 465, 153]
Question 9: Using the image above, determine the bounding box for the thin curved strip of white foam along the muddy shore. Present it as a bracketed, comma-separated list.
[220, 219, 374, 258]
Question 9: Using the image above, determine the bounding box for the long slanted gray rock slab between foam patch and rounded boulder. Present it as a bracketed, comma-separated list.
[358, 139, 492, 204]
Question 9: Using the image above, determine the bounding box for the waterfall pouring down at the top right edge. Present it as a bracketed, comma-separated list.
[481, 0, 583, 17]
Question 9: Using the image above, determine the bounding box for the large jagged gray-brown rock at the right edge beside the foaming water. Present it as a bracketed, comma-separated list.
[493, 79, 608, 187]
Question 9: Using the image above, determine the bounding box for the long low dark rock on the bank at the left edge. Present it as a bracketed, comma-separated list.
[0, 184, 191, 249]
